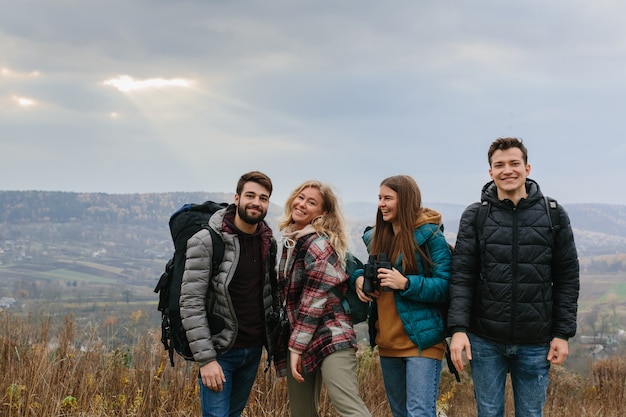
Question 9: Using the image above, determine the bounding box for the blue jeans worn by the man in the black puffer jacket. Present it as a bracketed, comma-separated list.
[468, 333, 550, 417]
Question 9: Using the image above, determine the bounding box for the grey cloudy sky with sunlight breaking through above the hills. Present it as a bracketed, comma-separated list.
[0, 0, 626, 204]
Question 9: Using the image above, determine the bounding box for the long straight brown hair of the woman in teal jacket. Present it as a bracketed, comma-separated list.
[371, 175, 422, 274]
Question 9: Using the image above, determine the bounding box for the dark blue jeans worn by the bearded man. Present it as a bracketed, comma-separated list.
[198, 347, 262, 417]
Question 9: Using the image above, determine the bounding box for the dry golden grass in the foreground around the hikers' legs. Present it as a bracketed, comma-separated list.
[0, 312, 626, 417]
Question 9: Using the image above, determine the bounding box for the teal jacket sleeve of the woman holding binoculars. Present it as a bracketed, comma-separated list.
[401, 231, 452, 303]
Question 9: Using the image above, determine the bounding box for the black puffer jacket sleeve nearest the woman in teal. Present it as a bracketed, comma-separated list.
[448, 203, 481, 333]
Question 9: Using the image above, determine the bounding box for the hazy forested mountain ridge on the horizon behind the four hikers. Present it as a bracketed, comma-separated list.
[0, 191, 626, 255]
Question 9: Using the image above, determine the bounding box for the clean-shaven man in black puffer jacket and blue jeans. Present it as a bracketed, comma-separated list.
[448, 138, 579, 417]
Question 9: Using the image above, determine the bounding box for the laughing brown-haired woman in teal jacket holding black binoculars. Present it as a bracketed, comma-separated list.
[355, 175, 452, 417]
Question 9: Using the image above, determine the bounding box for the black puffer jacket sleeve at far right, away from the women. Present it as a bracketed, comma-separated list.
[552, 205, 580, 340]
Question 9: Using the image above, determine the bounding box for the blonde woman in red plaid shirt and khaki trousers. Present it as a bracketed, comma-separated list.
[276, 181, 370, 417]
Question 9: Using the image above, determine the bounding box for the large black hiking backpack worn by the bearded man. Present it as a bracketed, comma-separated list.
[154, 201, 228, 366]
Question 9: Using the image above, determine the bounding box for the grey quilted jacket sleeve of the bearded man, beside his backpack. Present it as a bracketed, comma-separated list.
[180, 230, 217, 365]
